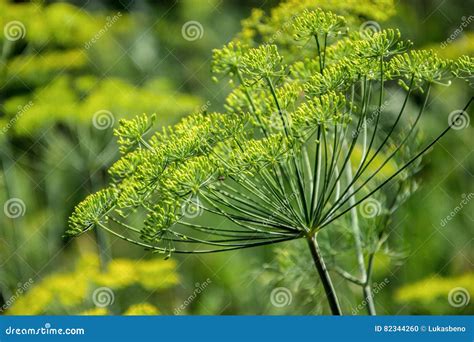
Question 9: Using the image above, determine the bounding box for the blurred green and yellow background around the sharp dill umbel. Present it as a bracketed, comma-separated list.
[0, 0, 474, 315]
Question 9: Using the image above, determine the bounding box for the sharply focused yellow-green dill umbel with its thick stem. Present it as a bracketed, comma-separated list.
[68, 9, 473, 314]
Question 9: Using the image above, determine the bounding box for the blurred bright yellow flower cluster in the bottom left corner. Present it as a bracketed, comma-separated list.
[7, 254, 179, 315]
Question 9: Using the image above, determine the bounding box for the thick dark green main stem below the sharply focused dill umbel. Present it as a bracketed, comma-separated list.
[307, 234, 342, 316]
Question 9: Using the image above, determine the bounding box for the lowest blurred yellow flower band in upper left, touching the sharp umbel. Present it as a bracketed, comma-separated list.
[0, 75, 201, 135]
